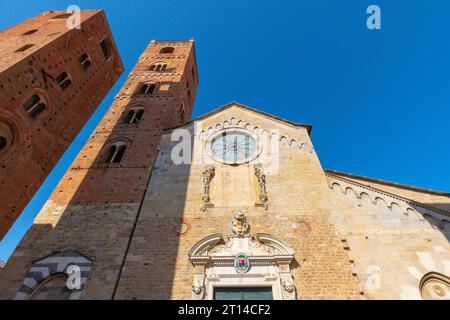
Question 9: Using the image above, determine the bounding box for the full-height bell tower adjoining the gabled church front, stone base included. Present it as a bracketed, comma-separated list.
[0, 40, 198, 299]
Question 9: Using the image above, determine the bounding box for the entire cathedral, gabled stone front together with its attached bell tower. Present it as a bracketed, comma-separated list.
[0, 35, 450, 300]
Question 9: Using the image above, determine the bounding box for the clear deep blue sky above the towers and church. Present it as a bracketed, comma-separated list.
[0, 0, 450, 260]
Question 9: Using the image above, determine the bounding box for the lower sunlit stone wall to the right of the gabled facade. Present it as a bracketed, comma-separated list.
[327, 171, 450, 299]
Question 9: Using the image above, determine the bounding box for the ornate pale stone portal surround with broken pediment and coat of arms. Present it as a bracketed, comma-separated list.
[188, 212, 296, 300]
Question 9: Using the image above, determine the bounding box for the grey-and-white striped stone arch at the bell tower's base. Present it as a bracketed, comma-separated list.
[14, 250, 92, 300]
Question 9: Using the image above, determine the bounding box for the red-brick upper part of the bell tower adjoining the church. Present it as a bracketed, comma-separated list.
[52, 40, 198, 205]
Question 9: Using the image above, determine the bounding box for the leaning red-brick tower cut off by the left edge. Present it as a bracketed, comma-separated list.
[0, 10, 123, 240]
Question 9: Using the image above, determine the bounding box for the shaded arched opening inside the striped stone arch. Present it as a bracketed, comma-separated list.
[30, 273, 71, 300]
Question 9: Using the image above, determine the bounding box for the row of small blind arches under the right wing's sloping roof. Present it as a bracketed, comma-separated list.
[326, 173, 450, 228]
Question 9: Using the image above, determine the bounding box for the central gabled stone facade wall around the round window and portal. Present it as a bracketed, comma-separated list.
[116, 103, 364, 299]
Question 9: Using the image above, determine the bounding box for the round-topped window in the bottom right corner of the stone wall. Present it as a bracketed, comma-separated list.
[420, 272, 450, 300]
